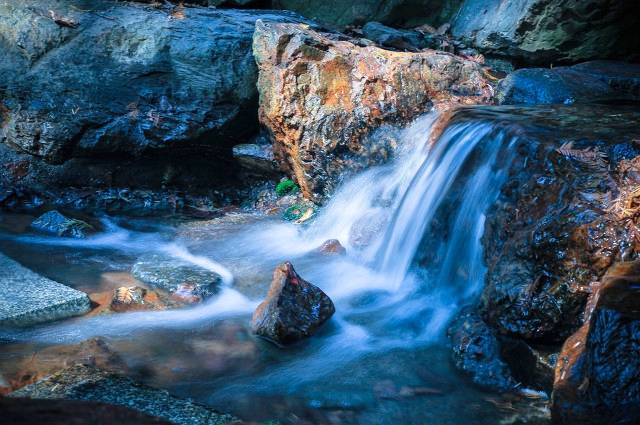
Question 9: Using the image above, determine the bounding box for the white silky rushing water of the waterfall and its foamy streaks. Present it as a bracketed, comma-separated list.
[0, 108, 515, 424]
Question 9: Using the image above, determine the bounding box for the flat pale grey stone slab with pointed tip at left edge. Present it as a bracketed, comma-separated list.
[0, 254, 91, 327]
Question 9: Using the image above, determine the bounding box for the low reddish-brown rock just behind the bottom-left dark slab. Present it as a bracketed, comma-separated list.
[6, 338, 128, 391]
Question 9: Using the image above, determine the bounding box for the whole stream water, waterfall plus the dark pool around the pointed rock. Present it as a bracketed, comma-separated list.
[0, 113, 552, 424]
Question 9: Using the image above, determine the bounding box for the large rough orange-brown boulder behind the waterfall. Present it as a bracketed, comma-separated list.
[253, 21, 492, 201]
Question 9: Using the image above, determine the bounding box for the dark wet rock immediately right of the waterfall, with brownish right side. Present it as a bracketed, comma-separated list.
[480, 105, 640, 345]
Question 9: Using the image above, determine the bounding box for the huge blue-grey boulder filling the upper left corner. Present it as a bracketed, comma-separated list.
[0, 0, 302, 163]
